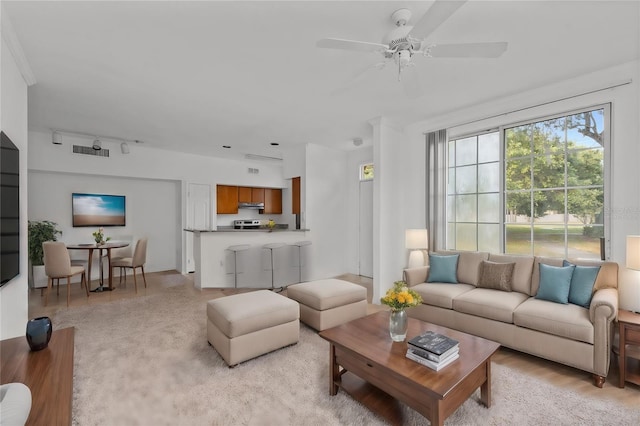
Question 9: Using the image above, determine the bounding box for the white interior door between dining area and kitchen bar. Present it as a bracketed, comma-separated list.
[185, 183, 211, 272]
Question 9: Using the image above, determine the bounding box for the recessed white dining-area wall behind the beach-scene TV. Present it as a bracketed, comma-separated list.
[29, 171, 182, 279]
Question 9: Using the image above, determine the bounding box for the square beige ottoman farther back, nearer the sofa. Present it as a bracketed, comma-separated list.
[287, 278, 367, 331]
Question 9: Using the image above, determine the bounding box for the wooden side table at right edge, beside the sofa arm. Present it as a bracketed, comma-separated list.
[618, 309, 640, 388]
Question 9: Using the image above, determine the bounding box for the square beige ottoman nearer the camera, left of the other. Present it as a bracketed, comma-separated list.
[207, 290, 300, 366]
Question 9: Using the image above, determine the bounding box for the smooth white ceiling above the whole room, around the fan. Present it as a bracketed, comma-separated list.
[2, 0, 640, 160]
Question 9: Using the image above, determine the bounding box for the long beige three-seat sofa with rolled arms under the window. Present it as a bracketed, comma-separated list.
[404, 251, 618, 387]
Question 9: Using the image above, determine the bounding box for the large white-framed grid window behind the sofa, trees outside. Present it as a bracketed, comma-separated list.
[447, 107, 609, 258]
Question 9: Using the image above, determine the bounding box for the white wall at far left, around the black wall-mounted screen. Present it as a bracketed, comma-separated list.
[0, 35, 28, 339]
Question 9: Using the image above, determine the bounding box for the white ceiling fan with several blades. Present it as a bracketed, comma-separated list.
[316, 0, 507, 97]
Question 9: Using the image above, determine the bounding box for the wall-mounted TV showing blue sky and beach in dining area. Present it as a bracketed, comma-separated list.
[71, 193, 127, 227]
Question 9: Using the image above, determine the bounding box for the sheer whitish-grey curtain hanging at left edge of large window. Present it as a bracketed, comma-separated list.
[425, 129, 447, 251]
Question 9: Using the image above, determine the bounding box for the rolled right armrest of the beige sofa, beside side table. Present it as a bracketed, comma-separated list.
[589, 288, 618, 378]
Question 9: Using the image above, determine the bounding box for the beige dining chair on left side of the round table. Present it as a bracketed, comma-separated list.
[42, 241, 89, 306]
